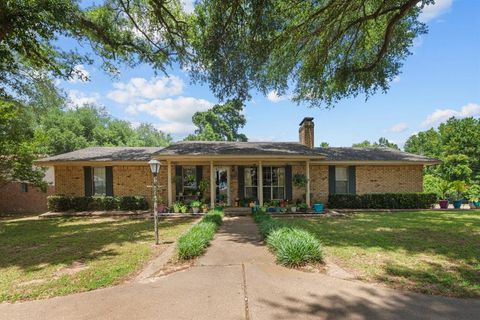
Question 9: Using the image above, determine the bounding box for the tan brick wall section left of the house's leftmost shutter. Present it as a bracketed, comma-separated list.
[55, 166, 85, 197]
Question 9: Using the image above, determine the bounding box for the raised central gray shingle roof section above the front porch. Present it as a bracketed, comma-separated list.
[155, 141, 320, 156]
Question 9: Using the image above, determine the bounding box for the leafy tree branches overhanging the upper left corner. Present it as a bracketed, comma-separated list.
[0, 0, 187, 102]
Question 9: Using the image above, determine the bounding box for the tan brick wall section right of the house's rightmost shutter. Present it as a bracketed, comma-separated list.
[356, 165, 423, 194]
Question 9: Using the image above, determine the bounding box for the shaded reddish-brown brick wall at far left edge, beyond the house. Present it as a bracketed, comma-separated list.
[0, 182, 55, 213]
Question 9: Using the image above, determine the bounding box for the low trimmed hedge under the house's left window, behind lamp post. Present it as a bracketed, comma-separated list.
[48, 196, 148, 212]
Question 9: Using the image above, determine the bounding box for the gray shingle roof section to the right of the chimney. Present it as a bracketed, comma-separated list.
[315, 147, 438, 163]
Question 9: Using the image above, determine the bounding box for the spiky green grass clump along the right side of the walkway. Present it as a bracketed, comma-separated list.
[253, 212, 323, 267]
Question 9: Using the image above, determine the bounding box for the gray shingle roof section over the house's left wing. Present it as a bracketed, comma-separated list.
[39, 147, 162, 162]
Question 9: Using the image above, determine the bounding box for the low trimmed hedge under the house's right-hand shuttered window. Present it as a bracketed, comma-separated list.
[328, 193, 437, 209]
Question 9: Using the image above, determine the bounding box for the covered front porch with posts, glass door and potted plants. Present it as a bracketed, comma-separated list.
[159, 158, 316, 207]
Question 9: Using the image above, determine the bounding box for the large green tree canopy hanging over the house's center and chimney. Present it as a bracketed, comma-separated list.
[191, 0, 434, 106]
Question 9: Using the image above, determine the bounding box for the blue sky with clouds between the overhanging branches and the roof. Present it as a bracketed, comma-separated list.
[59, 0, 480, 146]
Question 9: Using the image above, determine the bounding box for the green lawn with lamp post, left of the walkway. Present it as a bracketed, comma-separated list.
[0, 217, 193, 301]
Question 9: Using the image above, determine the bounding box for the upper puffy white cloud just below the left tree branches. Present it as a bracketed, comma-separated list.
[107, 76, 183, 103]
